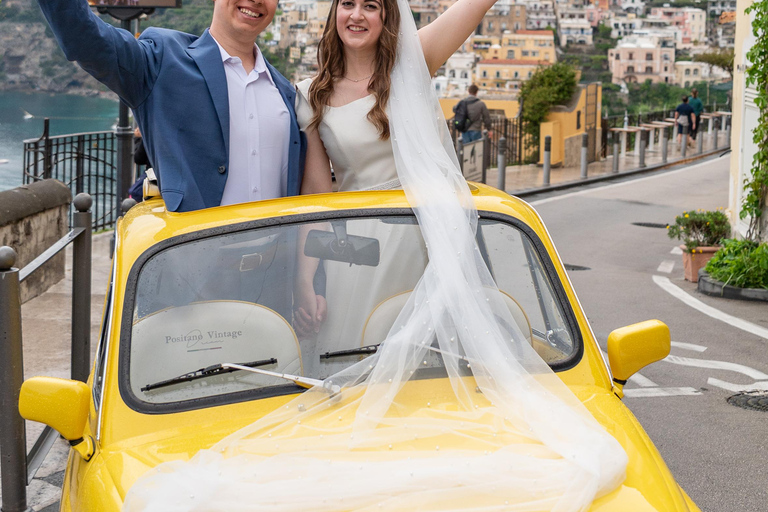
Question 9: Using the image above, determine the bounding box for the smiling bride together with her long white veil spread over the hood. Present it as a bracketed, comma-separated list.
[124, 0, 627, 512]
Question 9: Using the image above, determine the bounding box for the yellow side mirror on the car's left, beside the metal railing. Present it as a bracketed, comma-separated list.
[19, 377, 90, 441]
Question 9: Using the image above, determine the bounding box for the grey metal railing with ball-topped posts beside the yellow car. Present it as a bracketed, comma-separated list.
[0, 194, 93, 512]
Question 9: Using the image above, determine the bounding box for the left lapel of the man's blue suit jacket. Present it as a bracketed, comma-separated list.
[187, 29, 229, 155]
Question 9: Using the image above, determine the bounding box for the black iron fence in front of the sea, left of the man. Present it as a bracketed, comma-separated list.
[23, 119, 120, 231]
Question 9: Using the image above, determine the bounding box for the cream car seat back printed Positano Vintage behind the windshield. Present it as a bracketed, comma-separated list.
[130, 301, 303, 402]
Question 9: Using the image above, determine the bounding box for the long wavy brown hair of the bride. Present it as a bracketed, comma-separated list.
[309, 0, 400, 140]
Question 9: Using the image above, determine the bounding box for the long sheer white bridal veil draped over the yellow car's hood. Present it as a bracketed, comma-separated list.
[124, 0, 627, 512]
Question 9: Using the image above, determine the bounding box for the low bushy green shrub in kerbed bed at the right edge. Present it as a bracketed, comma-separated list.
[704, 239, 768, 289]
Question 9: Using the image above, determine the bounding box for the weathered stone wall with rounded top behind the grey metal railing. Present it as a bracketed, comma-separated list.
[0, 180, 72, 302]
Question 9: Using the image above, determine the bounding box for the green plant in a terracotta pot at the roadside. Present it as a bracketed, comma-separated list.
[667, 208, 731, 283]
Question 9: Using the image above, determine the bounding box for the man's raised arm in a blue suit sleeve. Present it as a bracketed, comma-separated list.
[38, 0, 162, 108]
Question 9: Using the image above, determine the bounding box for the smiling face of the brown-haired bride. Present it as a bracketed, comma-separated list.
[336, 0, 385, 50]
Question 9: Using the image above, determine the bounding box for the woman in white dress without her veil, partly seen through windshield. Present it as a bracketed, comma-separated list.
[294, 0, 496, 344]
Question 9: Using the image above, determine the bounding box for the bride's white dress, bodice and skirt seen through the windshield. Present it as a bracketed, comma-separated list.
[296, 79, 428, 378]
